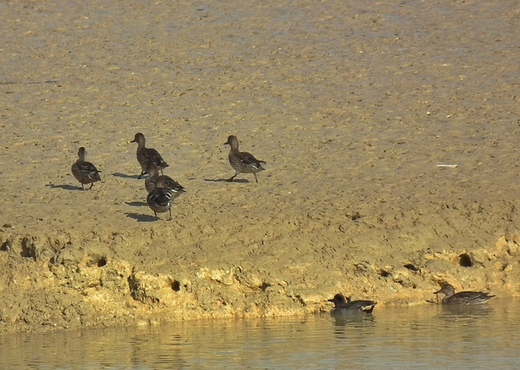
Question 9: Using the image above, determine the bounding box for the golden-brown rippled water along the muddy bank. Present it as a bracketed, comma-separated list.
[0, 300, 520, 369]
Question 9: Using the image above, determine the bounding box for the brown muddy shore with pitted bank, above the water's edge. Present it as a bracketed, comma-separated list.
[0, 0, 520, 332]
